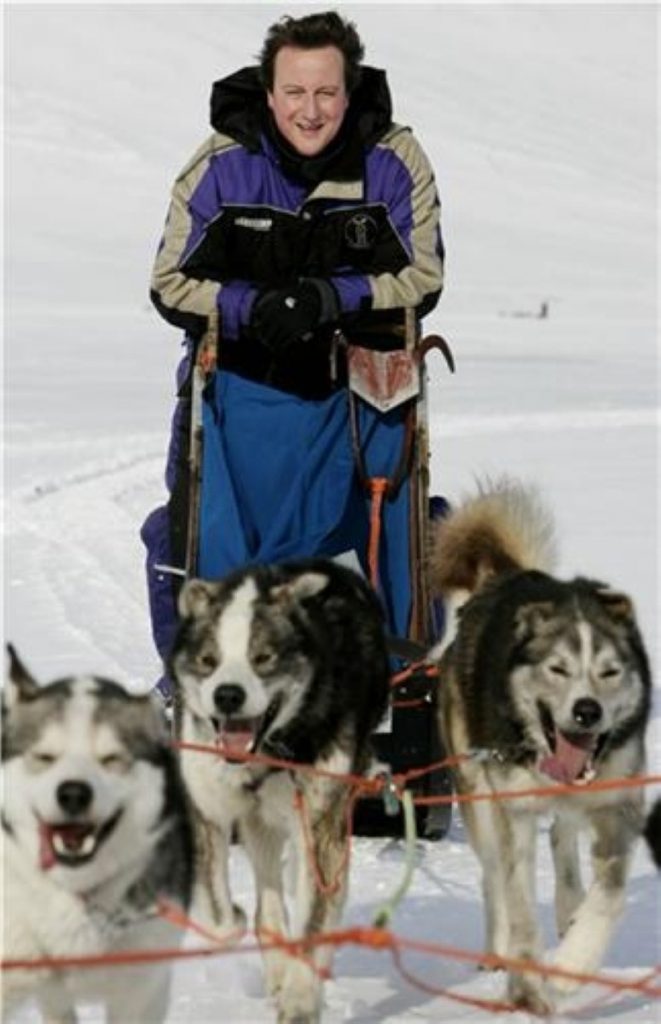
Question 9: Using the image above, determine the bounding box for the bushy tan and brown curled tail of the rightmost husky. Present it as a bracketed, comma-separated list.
[431, 477, 556, 605]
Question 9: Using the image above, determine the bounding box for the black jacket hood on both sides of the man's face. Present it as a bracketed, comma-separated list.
[211, 66, 392, 152]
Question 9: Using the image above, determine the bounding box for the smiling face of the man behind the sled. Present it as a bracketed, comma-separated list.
[267, 46, 349, 157]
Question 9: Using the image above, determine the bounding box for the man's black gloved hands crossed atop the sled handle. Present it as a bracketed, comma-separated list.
[250, 278, 340, 352]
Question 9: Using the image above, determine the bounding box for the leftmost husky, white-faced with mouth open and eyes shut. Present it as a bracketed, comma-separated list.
[2, 647, 192, 1024]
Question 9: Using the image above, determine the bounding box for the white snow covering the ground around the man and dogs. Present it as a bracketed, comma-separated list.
[4, 3, 661, 1024]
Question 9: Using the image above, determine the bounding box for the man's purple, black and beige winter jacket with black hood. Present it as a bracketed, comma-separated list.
[151, 68, 443, 397]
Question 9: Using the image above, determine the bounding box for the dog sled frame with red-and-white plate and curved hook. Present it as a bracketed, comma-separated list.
[185, 310, 454, 840]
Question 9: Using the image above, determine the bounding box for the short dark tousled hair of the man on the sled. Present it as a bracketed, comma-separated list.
[259, 10, 365, 92]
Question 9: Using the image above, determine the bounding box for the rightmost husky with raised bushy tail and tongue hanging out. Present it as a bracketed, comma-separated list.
[432, 479, 651, 1014]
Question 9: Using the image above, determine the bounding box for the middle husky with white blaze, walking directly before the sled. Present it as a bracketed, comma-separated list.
[169, 559, 390, 1024]
